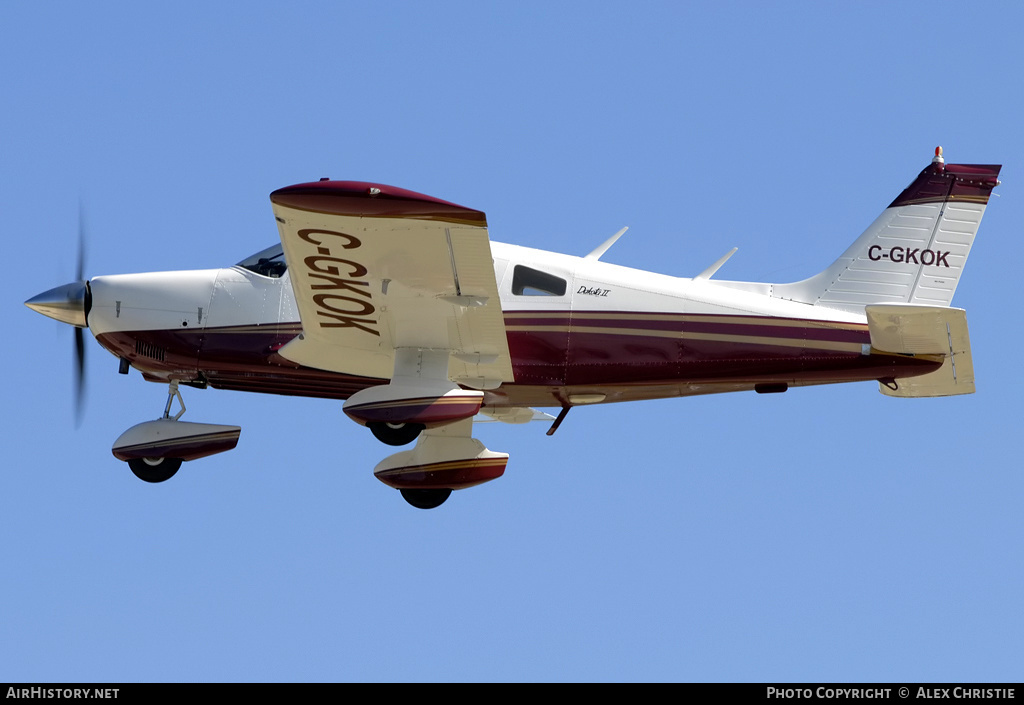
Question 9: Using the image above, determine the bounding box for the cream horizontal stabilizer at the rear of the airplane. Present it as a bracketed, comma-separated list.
[866, 304, 975, 397]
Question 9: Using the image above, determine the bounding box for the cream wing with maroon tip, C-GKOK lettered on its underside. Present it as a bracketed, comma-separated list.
[270, 181, 512, 389]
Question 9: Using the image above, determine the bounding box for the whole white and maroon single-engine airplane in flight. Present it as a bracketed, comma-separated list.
[26, 148, 1000, 508]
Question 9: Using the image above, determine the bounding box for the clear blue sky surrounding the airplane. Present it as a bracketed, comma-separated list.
[0, 2, 1024, 681]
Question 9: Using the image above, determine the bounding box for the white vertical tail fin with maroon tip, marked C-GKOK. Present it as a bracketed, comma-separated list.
[772, 148, 1000, 310]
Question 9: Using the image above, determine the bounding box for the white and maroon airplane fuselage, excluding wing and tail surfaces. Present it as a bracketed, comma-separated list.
[83, 242, 941, 407]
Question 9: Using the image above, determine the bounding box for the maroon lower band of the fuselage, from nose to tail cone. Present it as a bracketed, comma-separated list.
[97, 312, 939, 400]
